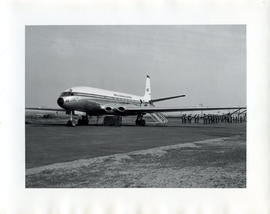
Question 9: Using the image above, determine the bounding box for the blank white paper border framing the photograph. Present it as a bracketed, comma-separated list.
[0, 0, 270, 214]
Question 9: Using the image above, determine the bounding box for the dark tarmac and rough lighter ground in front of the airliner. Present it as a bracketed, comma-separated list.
[25, 119, 246, 188]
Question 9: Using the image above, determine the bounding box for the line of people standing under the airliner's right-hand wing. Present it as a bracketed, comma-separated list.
[180, 113, 246, 124]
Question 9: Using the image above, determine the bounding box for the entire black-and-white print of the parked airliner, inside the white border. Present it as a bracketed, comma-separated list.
[25, 25, 247, 188]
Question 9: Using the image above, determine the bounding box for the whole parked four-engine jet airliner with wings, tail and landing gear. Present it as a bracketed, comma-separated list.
[27, 75, 245, 126]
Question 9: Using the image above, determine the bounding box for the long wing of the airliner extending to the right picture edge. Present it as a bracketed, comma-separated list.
[125, 106, 246, 114]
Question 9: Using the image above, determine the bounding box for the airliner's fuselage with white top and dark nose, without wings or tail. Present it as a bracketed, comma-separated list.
[57, 87, 146, 115]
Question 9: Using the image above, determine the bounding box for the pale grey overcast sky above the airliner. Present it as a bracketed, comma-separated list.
[25, 25, 246, 107]
